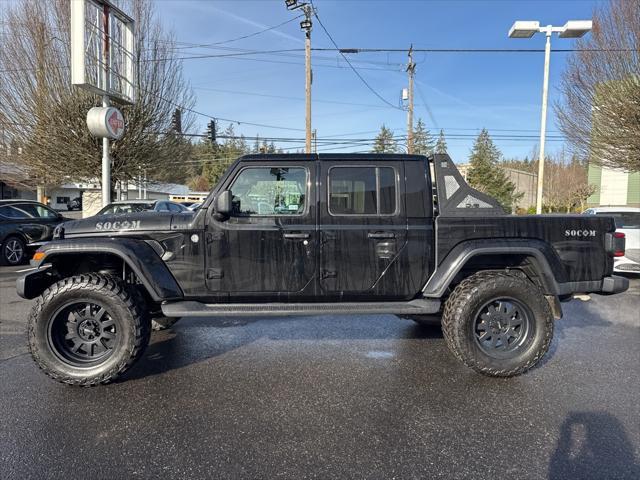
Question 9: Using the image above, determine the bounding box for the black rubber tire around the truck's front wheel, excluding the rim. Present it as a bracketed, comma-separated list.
[27, 273, 151, 387]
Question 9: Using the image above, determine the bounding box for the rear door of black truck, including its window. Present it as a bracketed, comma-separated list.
[319, 157, 407, 299]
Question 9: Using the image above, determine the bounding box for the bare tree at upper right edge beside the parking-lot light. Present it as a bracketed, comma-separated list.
[555, 0, 640, 171]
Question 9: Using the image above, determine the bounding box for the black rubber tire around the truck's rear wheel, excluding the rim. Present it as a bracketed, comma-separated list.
[442, 272, 553, 377]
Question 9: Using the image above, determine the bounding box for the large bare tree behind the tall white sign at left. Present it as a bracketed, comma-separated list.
[0, 0, 194, 188]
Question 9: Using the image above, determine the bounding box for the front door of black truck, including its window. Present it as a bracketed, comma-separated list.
[206, 161, 317, 301]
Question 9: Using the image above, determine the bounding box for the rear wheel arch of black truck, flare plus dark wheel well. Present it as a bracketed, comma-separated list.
[423, 239, 565, 298]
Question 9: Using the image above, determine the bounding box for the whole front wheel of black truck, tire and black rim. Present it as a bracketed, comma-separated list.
[28, 274, 151, 386]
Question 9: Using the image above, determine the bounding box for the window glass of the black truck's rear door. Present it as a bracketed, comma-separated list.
[329, 167, 397, 215]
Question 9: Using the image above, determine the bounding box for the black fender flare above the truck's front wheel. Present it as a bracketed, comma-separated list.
[17, 238, 184, 302]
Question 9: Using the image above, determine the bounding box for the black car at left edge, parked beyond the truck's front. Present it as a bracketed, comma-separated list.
[0, 199, 67, 265]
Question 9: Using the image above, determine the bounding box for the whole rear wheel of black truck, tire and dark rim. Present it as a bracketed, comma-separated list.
[442, 272, 553, 377]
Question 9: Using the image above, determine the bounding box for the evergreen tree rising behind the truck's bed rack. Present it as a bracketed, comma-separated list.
[467, 128, 522, 211]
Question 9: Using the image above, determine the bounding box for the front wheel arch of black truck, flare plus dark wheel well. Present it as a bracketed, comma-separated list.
[17, 239, 183, 302]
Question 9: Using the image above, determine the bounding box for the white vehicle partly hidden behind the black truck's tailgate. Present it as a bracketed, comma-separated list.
[584, 207, 640, 273]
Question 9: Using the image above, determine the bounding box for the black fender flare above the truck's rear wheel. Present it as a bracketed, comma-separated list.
[422, 239, 566, 298]
